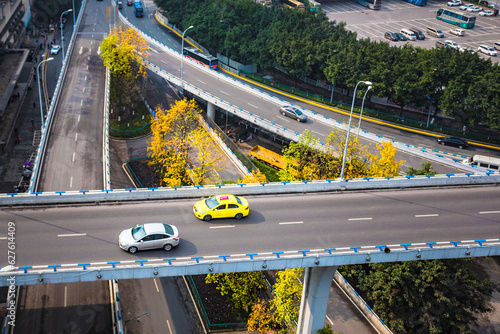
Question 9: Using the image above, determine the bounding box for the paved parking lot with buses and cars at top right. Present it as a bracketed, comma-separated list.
[321, 0, 500, 62]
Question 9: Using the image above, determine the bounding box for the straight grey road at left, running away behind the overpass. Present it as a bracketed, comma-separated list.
[39, 34, 105, 191]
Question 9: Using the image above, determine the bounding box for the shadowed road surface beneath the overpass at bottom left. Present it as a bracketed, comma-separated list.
[15, 281, 113, 334]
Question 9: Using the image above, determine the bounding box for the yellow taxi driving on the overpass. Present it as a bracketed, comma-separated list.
[193, 195, 250, 221]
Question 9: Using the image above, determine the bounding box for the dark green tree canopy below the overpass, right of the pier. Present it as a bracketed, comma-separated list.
[340, 259, 493, 334]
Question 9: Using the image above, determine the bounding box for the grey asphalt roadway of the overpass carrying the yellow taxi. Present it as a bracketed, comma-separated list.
[0, 187, 500, 267]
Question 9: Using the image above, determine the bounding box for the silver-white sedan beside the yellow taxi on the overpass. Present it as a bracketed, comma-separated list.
[118, 223, 179, 254]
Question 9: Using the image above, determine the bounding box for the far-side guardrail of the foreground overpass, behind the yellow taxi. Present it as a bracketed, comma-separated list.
[0, 173, 500, 207]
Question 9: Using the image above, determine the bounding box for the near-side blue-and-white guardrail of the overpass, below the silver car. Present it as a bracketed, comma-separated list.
[0, 238, 500, 286]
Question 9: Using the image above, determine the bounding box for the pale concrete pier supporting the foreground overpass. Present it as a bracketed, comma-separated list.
[297, 266, 338, 334]
